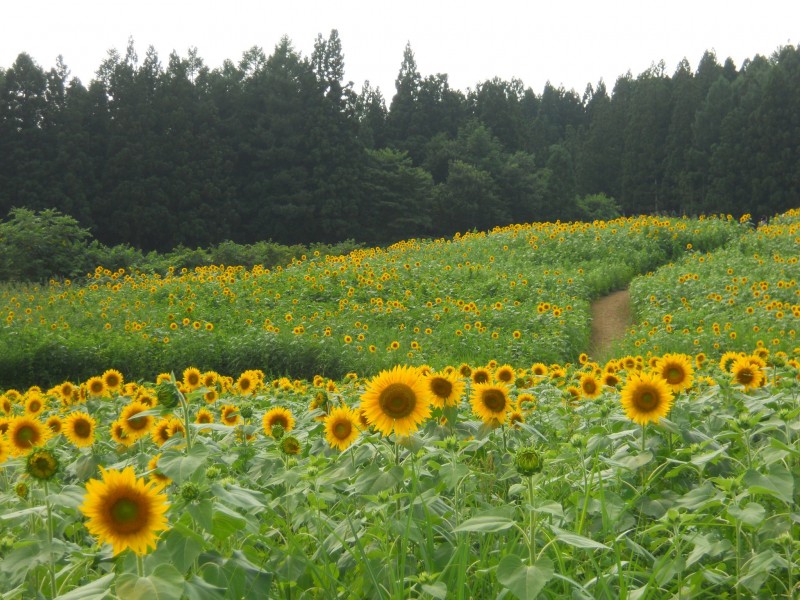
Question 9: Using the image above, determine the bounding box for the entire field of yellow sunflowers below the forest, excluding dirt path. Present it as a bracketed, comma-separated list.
[0, 211, 800, 600]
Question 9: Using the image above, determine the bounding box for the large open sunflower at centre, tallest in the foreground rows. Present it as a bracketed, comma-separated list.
[361, 365, 431, 436]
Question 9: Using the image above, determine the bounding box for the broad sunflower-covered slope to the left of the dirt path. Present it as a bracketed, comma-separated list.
[0, 217, 743, 385]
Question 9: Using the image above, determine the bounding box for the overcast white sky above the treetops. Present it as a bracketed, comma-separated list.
[0, 0, 800, 96]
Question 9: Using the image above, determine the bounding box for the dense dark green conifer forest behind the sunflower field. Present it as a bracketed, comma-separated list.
[0, 30, 800, 250]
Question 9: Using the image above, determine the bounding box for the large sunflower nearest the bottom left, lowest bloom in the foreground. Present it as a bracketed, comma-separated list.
[80, 467, 168, 555]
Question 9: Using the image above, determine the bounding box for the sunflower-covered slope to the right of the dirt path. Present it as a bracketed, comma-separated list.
[620, 210, 800, 358]
